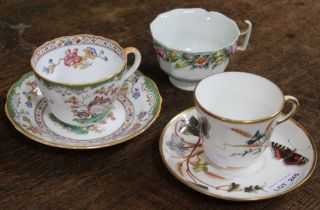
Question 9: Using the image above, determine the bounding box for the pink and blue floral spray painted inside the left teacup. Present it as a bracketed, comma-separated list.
[42, 47, 108, 74]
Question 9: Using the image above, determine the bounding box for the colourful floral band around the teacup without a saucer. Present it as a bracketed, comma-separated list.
[154, 42, 233, 70]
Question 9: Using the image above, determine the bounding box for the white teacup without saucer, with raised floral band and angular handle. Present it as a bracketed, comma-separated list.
[150, 8, 252, 91]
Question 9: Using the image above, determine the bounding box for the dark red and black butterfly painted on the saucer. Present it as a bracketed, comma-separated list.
[271, 142, 309, 166]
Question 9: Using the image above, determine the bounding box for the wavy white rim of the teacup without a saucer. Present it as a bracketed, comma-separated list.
[149, 8, 241, 54]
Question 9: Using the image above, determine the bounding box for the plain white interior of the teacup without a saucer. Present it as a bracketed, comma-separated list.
[150, 9, 240, 52]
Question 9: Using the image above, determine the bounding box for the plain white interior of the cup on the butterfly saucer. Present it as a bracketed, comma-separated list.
[194, 72, 284, 121]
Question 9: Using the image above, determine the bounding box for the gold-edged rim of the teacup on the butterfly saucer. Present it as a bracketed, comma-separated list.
[193, 71, 285, 124]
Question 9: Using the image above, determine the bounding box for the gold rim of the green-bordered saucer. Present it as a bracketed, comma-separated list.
[5, 75, 162, 150]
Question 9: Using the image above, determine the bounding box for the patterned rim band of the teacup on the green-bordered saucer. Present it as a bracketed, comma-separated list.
[30, 34, 127, 87]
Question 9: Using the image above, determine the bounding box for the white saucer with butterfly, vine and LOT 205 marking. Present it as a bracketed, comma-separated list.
[159, 107, 317, 201]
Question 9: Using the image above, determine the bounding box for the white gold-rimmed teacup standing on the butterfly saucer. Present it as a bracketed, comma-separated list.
[194, 72, 299, 168]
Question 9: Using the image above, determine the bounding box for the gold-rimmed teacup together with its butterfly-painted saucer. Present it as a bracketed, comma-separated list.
[160, 72, 317, 201]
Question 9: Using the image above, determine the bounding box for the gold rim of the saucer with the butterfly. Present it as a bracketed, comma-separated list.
[159, 107, 318, 201]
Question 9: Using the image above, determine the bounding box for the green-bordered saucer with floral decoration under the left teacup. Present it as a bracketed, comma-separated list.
[5, 71, 162, 149]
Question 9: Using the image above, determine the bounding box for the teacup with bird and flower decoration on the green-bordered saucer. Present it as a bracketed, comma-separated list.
[31, 34, 141, 127]
